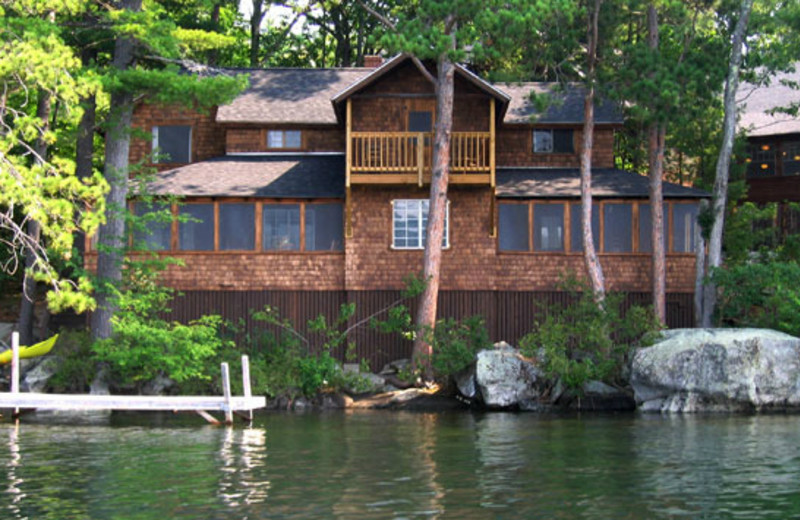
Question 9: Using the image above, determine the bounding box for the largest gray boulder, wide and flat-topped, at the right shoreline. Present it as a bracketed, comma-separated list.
[631, 329, 800, 412]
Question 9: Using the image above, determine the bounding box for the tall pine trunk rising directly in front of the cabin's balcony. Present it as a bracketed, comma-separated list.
[413, 50, 455, 381]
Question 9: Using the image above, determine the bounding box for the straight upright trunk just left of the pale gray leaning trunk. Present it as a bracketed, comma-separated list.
[647, 4, 667, 323]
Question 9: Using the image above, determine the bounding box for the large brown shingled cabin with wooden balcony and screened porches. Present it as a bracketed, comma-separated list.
[90, 56, 706, 367]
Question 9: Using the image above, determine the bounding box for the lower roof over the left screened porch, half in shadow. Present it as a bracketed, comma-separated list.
[148, 154, 345, 199]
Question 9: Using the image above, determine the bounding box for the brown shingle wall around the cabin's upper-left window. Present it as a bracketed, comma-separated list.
[129, 104, 225, 171]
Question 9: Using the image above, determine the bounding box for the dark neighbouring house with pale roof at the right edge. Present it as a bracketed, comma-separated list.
[736, 65, 800, 238]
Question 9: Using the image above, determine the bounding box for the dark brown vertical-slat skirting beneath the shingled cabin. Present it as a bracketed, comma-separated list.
[168, 290, 693, 371]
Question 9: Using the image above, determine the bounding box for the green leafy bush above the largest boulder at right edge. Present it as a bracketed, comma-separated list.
[712, 260, 800, 336]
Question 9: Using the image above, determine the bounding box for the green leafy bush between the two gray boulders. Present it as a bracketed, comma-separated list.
[520, 281, 661, 388]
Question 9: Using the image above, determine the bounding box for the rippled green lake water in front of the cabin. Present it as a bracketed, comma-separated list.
[0, 411, 800, 520]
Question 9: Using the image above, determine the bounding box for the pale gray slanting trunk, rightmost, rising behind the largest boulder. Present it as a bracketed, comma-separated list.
[702, 0, 753, 327]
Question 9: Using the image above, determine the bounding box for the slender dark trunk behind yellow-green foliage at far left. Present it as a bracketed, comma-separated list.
[17, 89, 53, 345]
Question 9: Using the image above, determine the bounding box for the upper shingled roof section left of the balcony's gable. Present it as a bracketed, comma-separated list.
[217, 68, 375, 124]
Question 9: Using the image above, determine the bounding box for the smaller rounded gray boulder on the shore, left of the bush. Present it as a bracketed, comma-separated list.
[476, 342, 542, 408]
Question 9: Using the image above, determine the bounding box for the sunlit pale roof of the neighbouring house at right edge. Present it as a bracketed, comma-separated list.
[736, 63, 800, 137]
